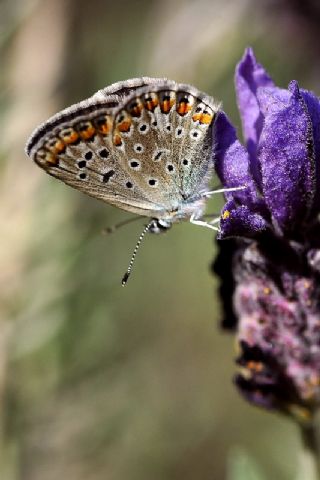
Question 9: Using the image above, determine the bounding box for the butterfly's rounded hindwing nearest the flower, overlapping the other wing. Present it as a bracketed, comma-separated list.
[113, 80, 219, 211]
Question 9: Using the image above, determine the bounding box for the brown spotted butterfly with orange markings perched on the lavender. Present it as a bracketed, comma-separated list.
[26, 77, 238, 285]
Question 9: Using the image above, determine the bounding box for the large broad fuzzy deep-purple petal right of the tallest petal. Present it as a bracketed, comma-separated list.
[258, 82, 315, 231]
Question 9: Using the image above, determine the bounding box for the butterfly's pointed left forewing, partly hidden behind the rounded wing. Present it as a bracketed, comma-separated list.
[26, 77, 172, 216]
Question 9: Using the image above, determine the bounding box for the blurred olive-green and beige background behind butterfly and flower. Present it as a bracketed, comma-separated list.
[0, 0, 320, 480]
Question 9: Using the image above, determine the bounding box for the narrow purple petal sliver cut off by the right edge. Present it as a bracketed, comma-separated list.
[300, 90, 320, 214]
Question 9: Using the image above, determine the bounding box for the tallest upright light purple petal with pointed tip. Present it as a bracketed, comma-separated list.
[235, 48, 274, 185]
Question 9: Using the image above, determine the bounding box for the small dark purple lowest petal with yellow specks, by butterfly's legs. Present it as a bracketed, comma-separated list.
[218, 200, 269, 240]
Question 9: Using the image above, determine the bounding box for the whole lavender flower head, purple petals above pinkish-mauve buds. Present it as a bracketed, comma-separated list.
[215, 49, 320, 419]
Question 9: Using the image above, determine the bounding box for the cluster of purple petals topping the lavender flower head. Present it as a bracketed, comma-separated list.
[216, 49, 320, 239]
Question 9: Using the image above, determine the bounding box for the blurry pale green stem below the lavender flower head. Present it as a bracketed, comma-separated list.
[297, 421, 320, 480]
